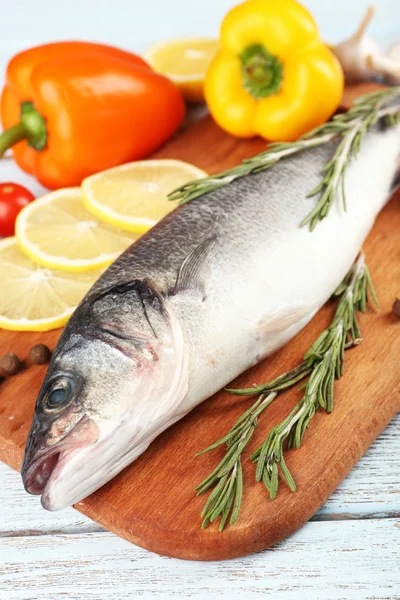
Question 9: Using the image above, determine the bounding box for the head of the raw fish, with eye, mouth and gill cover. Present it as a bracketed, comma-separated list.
[21, 282, 188, 510]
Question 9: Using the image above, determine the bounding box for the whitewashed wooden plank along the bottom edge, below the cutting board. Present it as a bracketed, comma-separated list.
[0, 519, 400, 600]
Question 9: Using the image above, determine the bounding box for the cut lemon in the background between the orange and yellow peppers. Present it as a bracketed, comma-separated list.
[145, 38, 219, 102]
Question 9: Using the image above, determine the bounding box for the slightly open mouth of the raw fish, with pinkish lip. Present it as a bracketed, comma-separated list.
[22, 415, 99, 497]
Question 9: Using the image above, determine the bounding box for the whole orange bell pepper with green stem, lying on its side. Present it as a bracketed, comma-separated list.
[0, 42, 185, 189]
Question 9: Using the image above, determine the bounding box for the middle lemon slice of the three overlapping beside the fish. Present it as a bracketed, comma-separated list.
[15, 188, 138, 272]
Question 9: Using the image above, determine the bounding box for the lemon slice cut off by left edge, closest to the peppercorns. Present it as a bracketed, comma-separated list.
[0, 237, 103, 331]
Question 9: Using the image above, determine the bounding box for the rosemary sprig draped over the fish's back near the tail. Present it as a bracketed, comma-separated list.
[169, 87, 400, 230]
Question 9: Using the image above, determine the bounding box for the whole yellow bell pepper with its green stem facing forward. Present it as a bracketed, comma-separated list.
[205, 0, 344, 141]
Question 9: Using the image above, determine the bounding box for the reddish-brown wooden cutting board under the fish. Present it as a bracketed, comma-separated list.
[0, 85, 400, 560]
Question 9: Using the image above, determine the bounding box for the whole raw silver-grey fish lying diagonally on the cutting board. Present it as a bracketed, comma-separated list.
[22, 126, 400, 510]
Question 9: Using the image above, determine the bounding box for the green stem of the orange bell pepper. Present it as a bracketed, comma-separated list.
[0, 102, 47, 157]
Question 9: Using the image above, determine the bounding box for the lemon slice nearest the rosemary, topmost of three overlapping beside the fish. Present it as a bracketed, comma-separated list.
[82, 159, 207, 233]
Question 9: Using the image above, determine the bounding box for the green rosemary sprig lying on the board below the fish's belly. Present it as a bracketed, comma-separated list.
[196, 254, 378, 531]
